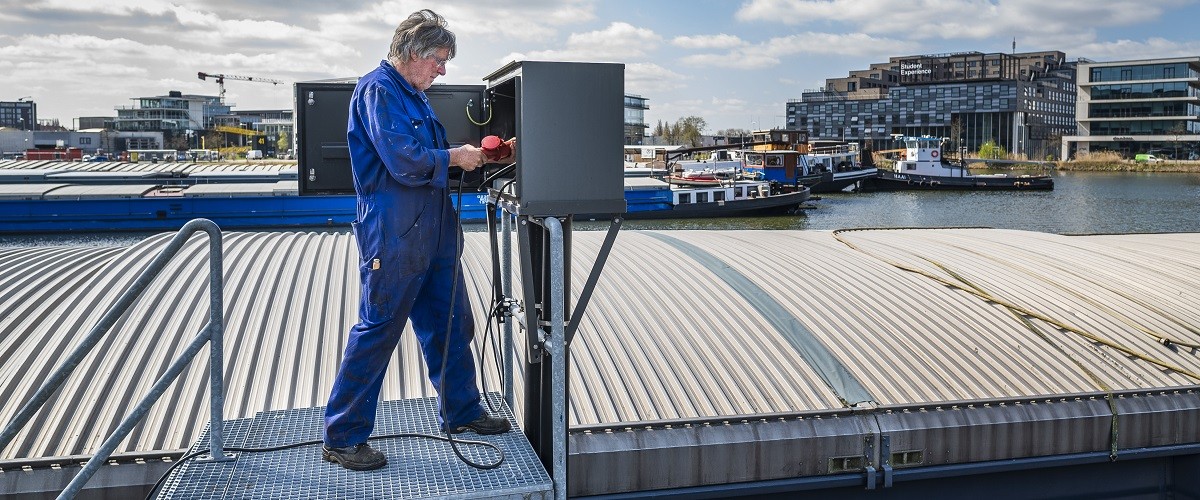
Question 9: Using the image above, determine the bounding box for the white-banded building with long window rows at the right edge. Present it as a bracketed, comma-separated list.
[1062, 58, 1200, 159]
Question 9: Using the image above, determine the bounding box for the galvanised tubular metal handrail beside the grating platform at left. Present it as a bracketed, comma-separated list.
[0, 218, 233, 499]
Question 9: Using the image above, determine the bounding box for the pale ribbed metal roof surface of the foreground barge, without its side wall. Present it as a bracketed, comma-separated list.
[0, 229, 1200, 458]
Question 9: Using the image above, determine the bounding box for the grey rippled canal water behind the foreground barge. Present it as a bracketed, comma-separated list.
[0, 171, 1200, 247]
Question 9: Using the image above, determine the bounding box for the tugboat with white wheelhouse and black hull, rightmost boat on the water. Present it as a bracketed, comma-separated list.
[863, 137, 1054, 191]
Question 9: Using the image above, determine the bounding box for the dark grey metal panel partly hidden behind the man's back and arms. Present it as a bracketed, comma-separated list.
[295, 78, 485, 195]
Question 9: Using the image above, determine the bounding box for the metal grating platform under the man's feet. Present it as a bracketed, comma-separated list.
[158, 393, 553, 500]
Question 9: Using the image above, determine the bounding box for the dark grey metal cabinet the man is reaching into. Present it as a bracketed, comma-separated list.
[484, 61, 625, 217]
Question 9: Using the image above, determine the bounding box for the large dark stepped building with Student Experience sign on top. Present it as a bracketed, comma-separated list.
[786, 52, 1076, 158]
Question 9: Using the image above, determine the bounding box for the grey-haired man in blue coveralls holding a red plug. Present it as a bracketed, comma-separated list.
[323, 10, 510, 470]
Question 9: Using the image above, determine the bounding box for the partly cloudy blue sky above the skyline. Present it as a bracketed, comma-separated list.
[0, 0, 1200, 133]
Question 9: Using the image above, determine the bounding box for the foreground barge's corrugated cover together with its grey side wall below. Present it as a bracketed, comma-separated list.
[0, 229, 1200, 493]
